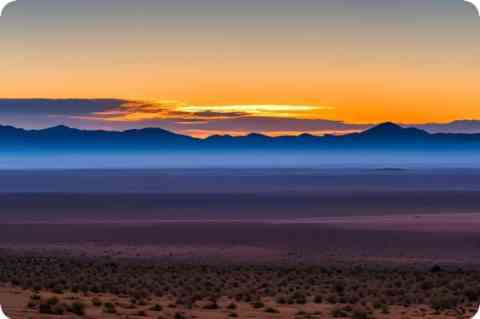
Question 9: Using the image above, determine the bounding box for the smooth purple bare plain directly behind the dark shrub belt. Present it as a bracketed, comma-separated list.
[4, 213, 480, 269]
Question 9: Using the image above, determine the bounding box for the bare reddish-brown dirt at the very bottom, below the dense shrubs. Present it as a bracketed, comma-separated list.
[0, 287, 475, 319]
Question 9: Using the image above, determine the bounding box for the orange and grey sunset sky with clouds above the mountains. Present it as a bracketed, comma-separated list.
[0, 0, 480, 136]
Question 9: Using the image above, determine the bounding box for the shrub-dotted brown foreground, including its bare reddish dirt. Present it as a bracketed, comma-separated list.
[0, 252, 480, 319]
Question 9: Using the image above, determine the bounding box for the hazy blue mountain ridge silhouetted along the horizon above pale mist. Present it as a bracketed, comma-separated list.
[0, 122, 480, 152]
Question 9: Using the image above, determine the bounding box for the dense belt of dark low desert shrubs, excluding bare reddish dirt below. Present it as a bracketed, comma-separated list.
[0, 254, 480, 319]
